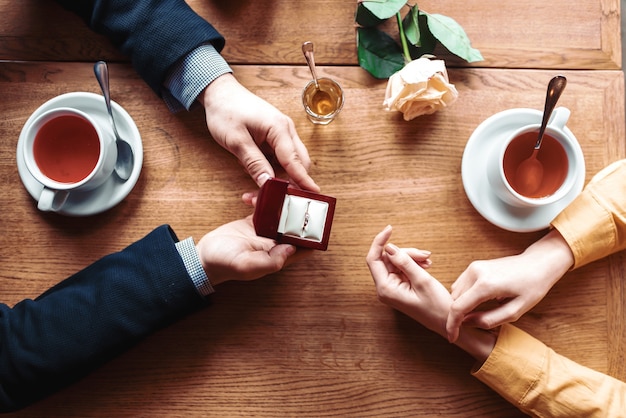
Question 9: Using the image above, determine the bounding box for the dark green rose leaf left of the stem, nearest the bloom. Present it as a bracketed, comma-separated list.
[357, 28, 404, 79]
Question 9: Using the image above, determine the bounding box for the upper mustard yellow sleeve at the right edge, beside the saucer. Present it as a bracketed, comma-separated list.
[552, 160, 626, 268]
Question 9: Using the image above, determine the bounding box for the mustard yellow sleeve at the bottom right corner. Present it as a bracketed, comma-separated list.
[472, 324, 626, 417]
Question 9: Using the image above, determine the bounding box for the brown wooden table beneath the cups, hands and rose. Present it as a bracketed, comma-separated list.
[0, 0, 626, 417]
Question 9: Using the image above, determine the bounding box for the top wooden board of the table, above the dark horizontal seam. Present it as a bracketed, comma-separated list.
[0, 0, 621, 69]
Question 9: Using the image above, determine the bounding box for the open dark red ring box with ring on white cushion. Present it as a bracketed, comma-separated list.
[252, 178, 337, 251]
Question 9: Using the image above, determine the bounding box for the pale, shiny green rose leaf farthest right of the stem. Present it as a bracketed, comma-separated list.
[420, 10, 483, 62]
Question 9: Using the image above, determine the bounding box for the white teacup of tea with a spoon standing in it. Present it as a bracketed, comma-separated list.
[486, 107, 585, 207]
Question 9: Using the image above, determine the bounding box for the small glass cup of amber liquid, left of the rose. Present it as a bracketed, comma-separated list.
[302, 77, 343, 125]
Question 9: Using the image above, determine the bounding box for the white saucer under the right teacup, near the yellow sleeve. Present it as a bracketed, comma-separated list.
[461, 109, 585, 232]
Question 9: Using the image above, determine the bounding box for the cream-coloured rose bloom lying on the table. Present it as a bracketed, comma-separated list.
[383, 57, 459, 120]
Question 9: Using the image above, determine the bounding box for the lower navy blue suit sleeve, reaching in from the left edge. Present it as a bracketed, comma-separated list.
[0, 225, 206, 411]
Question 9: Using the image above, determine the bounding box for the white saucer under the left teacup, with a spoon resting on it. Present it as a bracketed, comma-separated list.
[17, 92, 143, 216]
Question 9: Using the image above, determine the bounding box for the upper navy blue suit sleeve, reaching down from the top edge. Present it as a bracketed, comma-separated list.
[57, 0, 225, 95]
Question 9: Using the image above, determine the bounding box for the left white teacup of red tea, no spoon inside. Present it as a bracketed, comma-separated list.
[23, 107, 117, 211]
